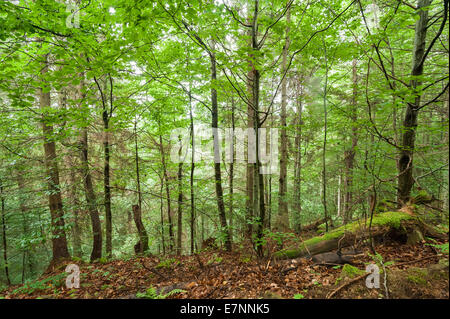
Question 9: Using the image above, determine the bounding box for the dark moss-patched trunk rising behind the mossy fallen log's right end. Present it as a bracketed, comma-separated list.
[398, 0, 430, 204]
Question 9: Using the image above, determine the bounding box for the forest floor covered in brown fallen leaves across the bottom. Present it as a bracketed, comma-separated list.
[0, 242, 449, 299]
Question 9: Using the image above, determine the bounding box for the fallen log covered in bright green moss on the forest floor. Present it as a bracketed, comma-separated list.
[273, 211, 438, 259]
